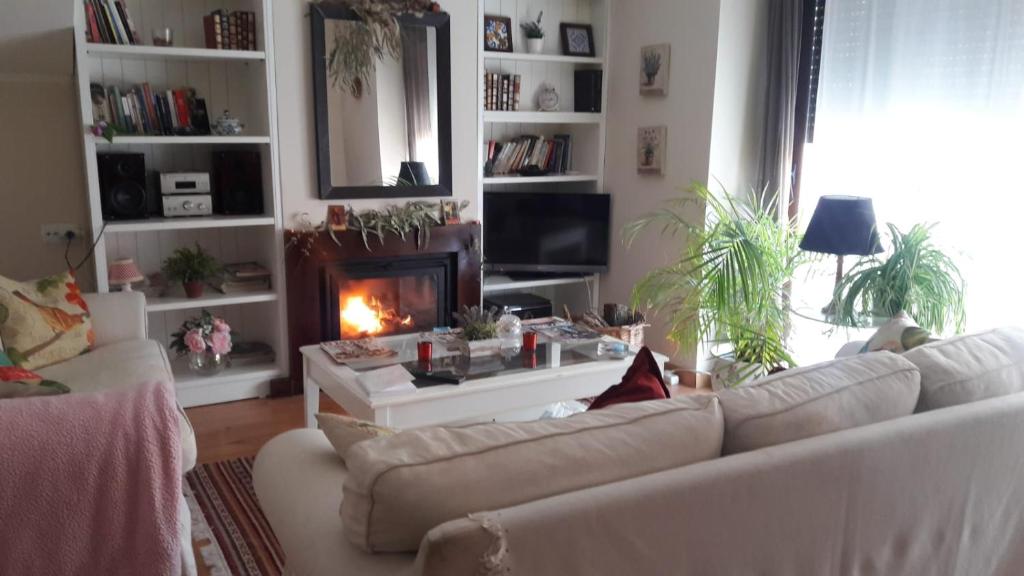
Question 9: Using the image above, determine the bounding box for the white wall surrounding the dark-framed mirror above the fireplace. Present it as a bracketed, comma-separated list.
[273, 0, 480, 225]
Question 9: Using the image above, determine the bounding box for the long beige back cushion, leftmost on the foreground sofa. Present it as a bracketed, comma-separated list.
[341, 396, 722, 551]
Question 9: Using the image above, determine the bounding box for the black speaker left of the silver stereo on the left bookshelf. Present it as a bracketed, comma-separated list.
[96, 153, 148, 220]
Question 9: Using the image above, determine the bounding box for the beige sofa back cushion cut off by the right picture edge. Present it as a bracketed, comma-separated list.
[903, 328, 1024, 412]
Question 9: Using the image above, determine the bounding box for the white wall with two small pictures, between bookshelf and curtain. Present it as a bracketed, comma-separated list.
[601, 0, 720, 363]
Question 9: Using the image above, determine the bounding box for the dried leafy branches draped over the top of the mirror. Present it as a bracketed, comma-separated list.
[313, 0, 441, 98]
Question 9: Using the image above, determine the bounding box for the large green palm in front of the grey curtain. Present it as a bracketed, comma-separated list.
[625, 182, 806, 380]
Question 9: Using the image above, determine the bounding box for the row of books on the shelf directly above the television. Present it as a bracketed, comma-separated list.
[486, 134, 572, 175]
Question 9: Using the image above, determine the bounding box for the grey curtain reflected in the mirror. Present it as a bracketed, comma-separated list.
[401, 26, 434, 161]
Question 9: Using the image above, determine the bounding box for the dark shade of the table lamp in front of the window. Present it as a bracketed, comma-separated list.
[800, 196, 882, 256]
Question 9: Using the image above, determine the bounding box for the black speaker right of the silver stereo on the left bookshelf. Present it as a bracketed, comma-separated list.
[212, 150, 263, 215]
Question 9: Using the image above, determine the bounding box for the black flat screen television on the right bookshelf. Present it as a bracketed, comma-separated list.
[483, 192, 611, 274]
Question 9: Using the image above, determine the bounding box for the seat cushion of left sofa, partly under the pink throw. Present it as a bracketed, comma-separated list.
[38, 340, 197, 471]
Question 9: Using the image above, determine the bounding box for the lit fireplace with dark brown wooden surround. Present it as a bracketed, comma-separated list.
[280, 222, 481, 396]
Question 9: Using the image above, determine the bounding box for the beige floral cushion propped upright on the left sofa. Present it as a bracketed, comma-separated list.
[0, 272, 95, 370]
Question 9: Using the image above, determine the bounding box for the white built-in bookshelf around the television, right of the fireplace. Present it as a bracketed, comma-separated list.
[477, 0, 611, 314]
